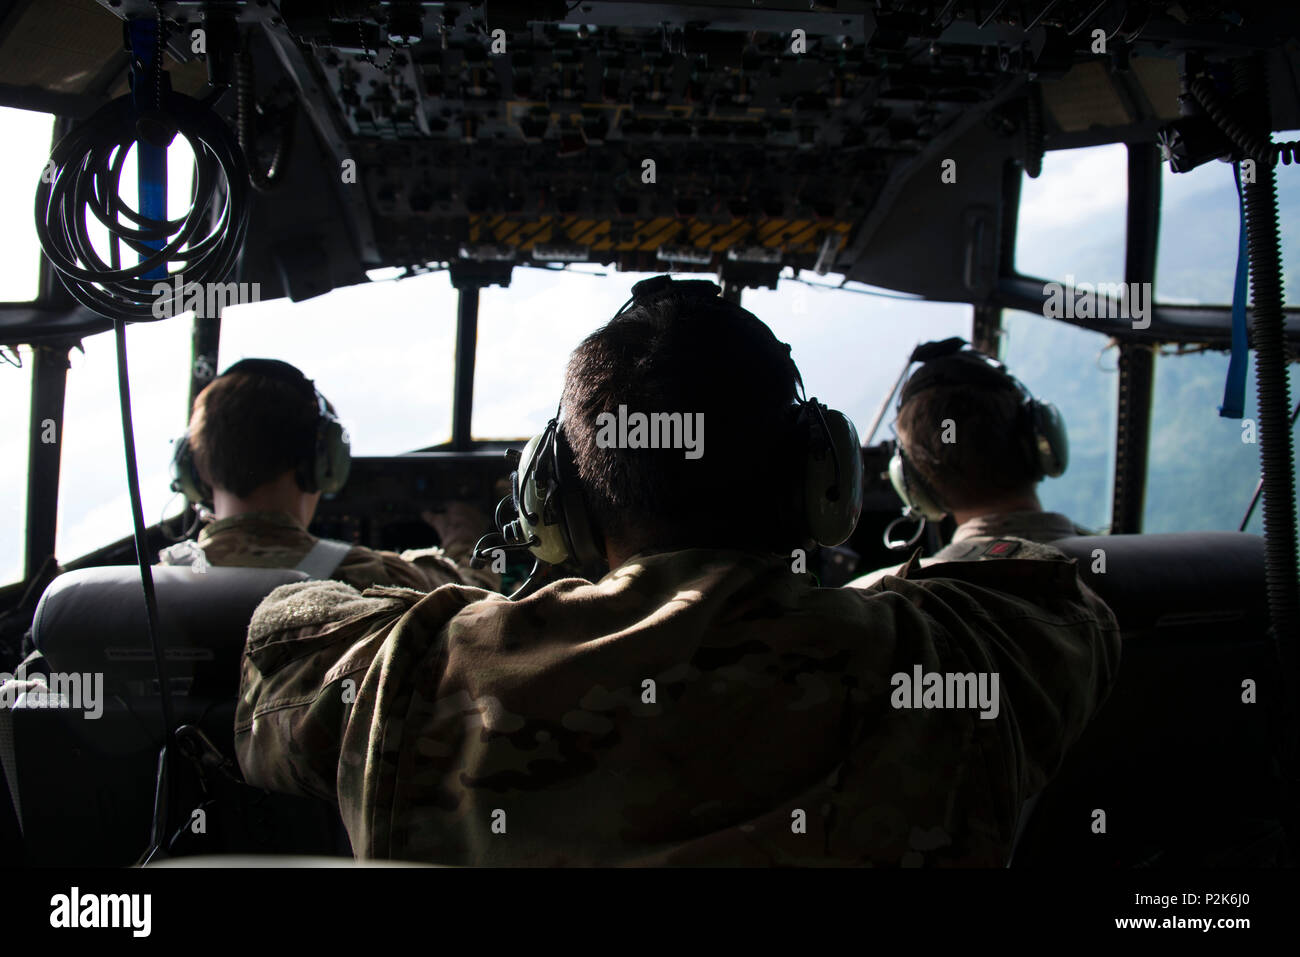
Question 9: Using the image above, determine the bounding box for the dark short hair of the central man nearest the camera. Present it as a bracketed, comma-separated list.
[562, 293, 798, 550]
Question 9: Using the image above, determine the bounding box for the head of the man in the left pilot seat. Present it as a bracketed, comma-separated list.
[187, 359, 347, 518]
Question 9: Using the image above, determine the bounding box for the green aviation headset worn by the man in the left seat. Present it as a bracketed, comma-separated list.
[172, 359, 352, 507]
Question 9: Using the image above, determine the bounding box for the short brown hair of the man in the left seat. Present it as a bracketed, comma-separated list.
[190, 372, 320, 498]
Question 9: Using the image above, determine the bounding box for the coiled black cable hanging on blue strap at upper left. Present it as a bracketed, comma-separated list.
[35, 92, 248, 321]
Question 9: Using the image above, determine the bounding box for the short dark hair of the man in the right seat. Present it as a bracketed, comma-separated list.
[896, 359, 1039, 508]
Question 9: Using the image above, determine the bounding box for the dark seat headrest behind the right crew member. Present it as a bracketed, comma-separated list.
[1052, 532, 1268, 631]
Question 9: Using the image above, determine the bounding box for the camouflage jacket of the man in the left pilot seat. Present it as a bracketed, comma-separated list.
[166, 512, 501, 592]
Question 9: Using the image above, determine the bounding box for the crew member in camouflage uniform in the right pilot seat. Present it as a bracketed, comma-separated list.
[850, 340, 1093, 586]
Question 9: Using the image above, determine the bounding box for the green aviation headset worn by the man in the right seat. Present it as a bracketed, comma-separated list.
[889, 338, 1070, 521]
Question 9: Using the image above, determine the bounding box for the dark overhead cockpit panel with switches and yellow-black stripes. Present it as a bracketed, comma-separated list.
[0, 0, 1300, 314]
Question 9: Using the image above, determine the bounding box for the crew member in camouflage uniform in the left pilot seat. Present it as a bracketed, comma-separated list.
[163, 360, 501, 592]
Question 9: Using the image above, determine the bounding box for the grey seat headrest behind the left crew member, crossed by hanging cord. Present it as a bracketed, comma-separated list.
[31, 566, 307, 693]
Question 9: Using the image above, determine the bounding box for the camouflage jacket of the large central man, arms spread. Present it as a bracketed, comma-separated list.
[235, 550, 1119, 866]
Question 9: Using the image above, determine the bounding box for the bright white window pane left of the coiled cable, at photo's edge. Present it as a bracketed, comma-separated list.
[0, 107, 55, 302]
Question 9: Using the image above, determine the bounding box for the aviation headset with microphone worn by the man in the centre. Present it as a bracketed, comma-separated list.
[475, 276, 863, 579]
